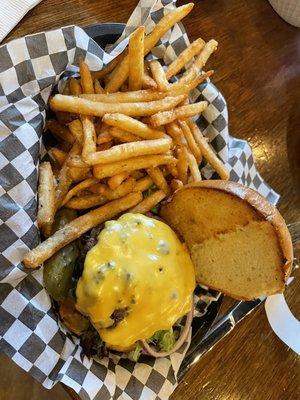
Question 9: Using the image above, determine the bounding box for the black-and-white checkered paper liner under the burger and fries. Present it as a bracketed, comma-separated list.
[0, 0, 279, 400]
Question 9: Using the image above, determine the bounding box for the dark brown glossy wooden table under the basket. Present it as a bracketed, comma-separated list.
[7, 0, 300, 400]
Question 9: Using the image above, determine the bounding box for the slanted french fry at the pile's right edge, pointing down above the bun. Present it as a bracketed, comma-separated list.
[188, 119, 230, 180]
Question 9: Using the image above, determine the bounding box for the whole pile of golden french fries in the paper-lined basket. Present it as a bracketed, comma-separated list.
[24, 4, 229, 268]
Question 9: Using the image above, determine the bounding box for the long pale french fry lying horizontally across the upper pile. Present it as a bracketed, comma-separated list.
[50, 94, 186, 117]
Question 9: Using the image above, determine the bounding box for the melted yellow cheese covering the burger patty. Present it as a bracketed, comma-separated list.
[76, 213, 195, 348]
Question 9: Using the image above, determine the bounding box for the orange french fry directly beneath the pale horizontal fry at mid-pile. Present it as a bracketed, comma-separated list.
[93, 154, 177, 179]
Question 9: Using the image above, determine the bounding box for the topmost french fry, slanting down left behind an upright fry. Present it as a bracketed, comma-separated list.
[105, 3, 194, 93]
